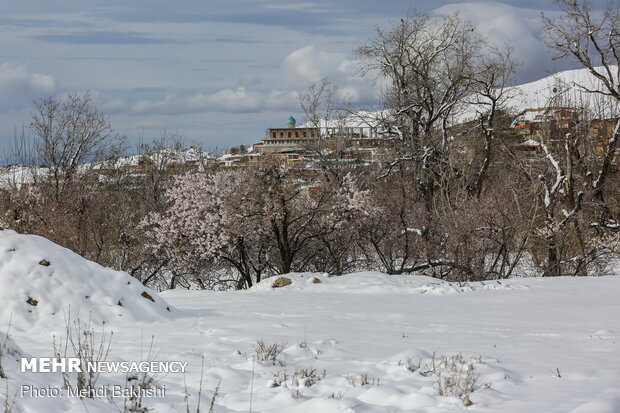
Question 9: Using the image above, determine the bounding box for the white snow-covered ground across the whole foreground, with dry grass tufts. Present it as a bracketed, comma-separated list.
[0, 231, 620, 413]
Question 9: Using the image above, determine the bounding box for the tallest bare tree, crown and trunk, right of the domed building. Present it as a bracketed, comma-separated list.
[356, 14, 484, 214]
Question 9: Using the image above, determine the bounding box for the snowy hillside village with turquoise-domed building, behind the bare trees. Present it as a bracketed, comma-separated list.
[0, 69, 619, 186]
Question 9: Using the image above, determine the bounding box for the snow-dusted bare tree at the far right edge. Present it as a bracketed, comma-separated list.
[540, 0, 620, 275]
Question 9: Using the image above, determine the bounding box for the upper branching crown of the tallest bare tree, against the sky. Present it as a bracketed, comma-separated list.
[356, 14, 481, 148]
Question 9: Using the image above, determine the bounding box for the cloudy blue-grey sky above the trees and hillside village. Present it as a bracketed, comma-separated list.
[0, 0, 604, 158]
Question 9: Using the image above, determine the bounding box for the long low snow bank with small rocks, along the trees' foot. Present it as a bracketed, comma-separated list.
[251, 271, 528, 295]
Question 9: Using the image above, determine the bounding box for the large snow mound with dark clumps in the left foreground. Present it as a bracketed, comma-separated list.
[0, 230, 172, 328]
